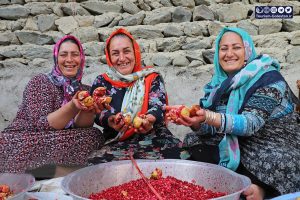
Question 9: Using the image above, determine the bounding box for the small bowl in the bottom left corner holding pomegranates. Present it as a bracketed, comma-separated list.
[0, 173, 35, 200]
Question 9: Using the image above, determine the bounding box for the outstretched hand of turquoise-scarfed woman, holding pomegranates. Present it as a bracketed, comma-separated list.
[166, 105, 206, 128]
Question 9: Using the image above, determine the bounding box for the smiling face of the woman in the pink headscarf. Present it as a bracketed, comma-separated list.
[57, 41, 81, 78]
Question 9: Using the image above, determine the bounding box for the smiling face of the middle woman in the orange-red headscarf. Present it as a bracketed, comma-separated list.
[108, 35, 135, 75]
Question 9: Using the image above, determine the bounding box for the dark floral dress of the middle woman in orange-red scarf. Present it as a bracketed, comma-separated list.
[89, 75, 187, 164]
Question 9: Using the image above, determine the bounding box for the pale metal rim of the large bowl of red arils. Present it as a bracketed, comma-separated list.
[61, 159, 251, 200]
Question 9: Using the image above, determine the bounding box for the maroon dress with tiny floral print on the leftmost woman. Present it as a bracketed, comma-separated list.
[0, 74, 104, 173]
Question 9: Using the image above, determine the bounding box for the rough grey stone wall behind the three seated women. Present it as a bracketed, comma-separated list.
[0, 0, 300, 138]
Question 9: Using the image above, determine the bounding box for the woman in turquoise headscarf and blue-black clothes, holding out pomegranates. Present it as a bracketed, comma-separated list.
[167, 27, 300, 199]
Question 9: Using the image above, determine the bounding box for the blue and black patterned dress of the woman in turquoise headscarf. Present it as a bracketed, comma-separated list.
[183, 81, 300, 197]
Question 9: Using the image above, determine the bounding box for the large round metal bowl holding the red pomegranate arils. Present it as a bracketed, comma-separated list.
[62, 159, 251, 200]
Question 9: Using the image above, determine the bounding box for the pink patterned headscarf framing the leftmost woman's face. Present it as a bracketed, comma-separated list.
[48, 35, 85, 105]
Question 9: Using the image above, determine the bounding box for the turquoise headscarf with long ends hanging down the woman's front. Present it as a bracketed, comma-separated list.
[200, 27, 280, 171]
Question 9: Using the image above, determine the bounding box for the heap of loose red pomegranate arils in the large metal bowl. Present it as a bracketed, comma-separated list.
[89, 176, 227, 200]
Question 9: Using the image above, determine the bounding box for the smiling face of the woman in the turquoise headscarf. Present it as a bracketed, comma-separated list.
[219, 32, 245, 74]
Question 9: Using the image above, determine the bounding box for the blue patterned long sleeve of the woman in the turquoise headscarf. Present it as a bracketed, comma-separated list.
[219, 81, 293, 136]
